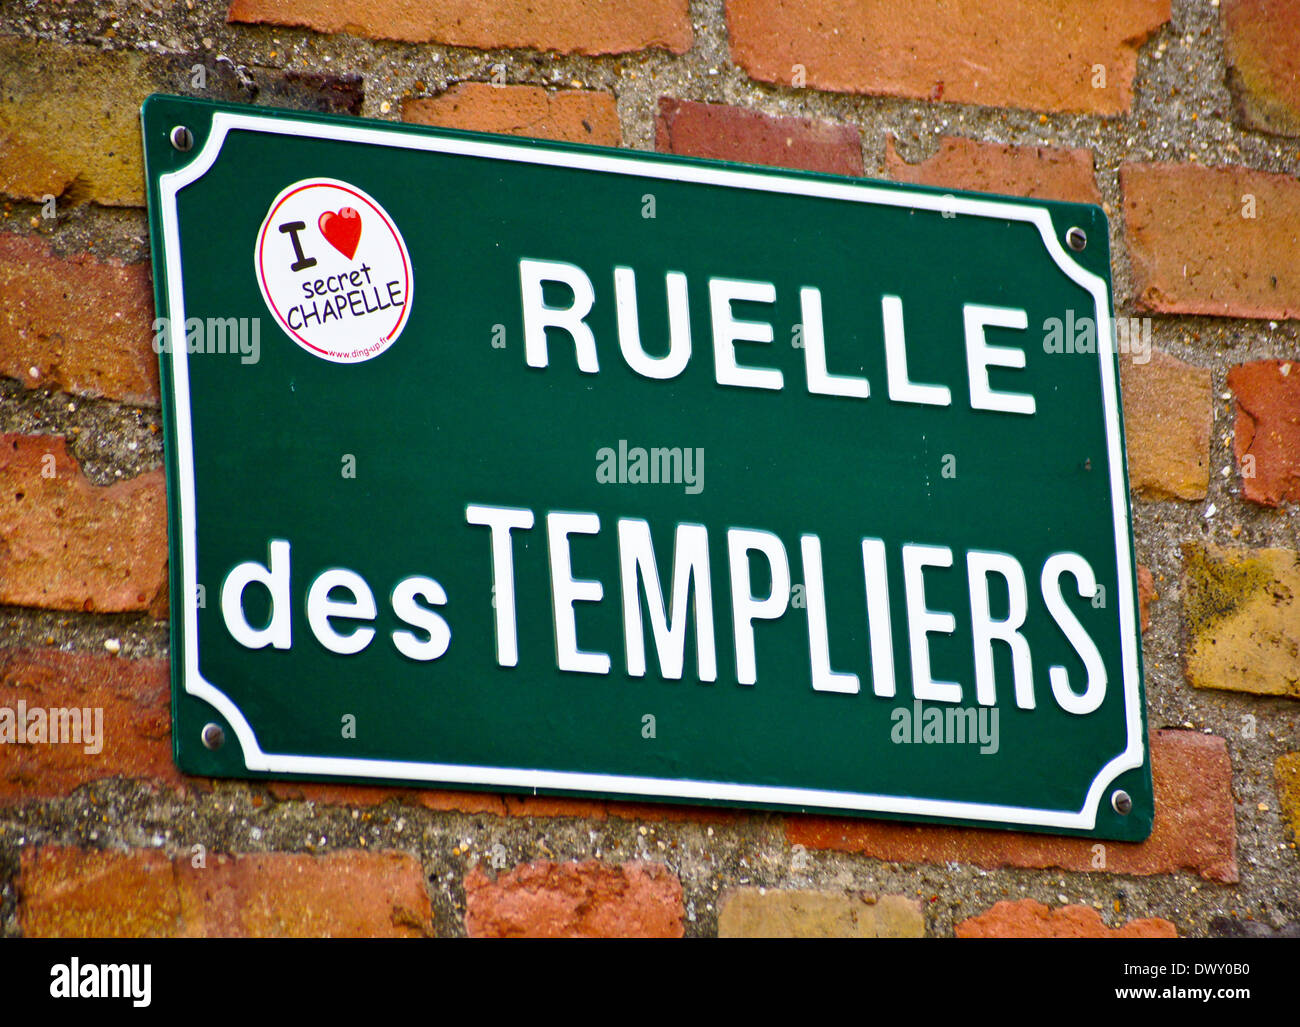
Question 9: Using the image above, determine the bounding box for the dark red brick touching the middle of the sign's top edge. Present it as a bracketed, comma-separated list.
[655, 96, 862, 174]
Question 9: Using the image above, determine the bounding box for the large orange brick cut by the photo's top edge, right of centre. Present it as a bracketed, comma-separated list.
[727, 0, 1169, 114]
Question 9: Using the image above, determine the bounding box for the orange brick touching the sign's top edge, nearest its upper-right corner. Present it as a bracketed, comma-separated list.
[885, 135, 1101, 207]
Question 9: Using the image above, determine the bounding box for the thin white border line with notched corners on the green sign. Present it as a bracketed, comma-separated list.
[159, 111, 1144, 831]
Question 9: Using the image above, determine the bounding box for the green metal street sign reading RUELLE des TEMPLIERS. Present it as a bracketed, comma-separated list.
[143, 96, 1153, 840]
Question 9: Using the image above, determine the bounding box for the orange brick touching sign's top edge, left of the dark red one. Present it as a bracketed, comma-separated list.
[402, 82, 623, 146]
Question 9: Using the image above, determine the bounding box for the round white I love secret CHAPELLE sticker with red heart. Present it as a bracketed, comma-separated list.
[254, 178, 412, 364]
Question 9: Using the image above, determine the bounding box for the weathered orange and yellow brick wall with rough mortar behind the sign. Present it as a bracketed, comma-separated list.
[0, 0, 1300, 937]
